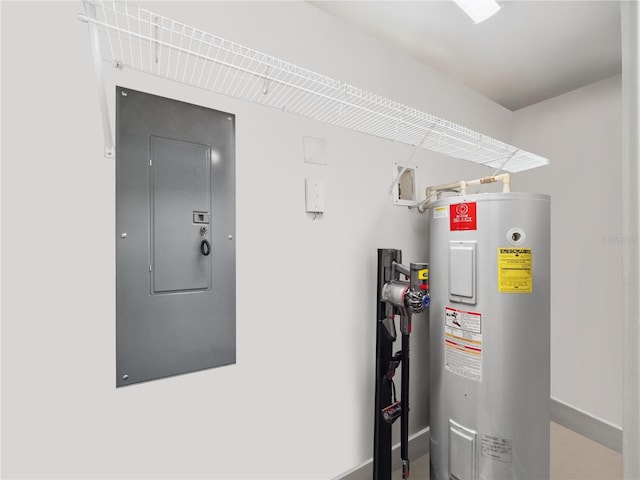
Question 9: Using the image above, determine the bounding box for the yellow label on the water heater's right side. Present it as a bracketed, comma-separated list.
[498, 248, 533, 293]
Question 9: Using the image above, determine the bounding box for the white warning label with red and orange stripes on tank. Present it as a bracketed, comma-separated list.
[444, 307, 482, 382]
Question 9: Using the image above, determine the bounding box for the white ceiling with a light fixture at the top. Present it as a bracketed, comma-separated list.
[310, 0, 622, 110]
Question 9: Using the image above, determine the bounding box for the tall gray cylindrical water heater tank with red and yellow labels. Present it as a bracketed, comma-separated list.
[428, 193, 550, 480]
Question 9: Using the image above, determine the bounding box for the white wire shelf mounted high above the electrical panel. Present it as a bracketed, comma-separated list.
[80, 0, 549, 173]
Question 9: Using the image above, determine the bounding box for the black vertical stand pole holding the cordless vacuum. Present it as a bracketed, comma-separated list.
[373, 249, 402, 480]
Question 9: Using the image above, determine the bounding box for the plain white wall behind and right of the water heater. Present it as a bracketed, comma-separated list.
[513, 76, 624, 427]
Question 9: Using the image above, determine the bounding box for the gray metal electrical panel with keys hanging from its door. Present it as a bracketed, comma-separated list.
[116, 87, 236, 386]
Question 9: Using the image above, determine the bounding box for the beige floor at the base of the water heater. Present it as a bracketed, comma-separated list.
[392, 422, 622, 480]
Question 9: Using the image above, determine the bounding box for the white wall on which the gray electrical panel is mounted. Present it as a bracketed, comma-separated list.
[1, 2, 510, 478]
